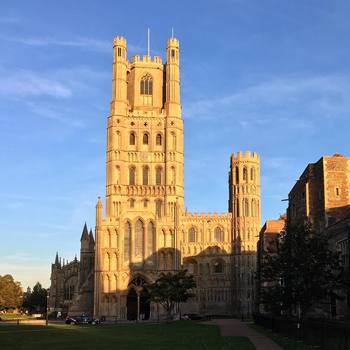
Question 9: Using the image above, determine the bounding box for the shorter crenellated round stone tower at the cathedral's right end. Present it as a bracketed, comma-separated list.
[229, 151, 261, 315]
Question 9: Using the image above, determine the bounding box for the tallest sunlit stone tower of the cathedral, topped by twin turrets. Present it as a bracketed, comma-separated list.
[94, 36, 184, 318]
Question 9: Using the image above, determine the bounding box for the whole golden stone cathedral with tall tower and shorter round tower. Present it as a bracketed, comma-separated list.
[49, 36, 261, 320]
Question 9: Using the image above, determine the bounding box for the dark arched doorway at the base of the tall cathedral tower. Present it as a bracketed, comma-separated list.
[126, 277, 151, 321]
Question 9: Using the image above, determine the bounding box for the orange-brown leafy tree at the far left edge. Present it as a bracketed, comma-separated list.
[0, 275, 23, 310]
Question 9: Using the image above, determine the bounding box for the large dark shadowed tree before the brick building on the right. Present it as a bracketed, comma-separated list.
[261, 224, 343, 320]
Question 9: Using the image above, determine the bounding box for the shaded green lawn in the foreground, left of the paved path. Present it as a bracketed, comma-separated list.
[0, 321, 255, 350]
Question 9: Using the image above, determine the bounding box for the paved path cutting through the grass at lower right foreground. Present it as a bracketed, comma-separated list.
[208, 319, 283, 350]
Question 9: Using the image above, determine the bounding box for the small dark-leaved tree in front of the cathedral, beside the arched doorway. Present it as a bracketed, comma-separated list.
[147, 270, 196, 320]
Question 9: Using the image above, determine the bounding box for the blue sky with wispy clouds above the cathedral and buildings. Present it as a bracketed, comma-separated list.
[0, 0, 350, 287]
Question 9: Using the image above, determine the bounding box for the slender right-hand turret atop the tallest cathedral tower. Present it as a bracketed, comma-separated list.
[165, 38, 181, 118]
